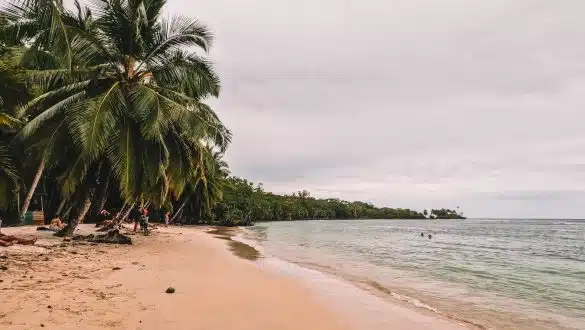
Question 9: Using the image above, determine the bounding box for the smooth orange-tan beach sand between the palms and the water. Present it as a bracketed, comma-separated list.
[0, 225, 466, 330]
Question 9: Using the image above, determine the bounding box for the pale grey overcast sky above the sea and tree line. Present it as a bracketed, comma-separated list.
[61, 0, 585, 218]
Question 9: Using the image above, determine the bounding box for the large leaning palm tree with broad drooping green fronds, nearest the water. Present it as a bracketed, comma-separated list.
[4, 0, 231, 230]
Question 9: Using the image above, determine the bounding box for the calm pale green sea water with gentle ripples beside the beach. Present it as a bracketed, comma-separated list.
[245, 220, 585, 329]
